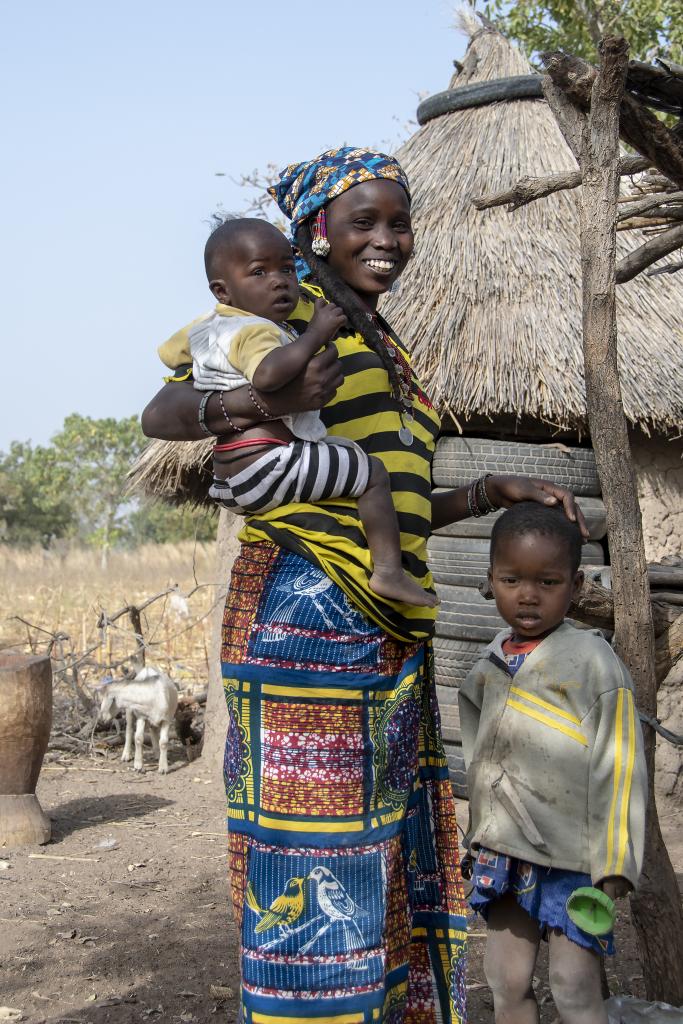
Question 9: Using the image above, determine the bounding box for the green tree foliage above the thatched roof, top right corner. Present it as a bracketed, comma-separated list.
[484, 0, 683, 62]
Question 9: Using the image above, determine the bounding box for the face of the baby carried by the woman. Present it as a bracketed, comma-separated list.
[209, 224, 299, 323]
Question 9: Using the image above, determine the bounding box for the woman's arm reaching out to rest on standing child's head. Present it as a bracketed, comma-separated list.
[432, 475, 589, 541]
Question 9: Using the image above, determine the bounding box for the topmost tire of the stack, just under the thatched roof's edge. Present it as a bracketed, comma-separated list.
[432, 437, 600, 496]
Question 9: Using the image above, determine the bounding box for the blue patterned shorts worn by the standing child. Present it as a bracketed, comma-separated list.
[469, 848, 614, 956]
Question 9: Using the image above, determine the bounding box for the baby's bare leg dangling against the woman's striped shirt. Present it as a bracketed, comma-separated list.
[358, 457, 438, 607]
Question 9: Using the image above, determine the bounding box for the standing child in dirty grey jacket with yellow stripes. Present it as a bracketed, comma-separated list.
[459, 502, 646, 1024]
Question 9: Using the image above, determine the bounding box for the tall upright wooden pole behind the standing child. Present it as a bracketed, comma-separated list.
[581, 38, 683, 1006]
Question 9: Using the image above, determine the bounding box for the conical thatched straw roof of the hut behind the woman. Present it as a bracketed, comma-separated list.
[382, 29, 683, 430]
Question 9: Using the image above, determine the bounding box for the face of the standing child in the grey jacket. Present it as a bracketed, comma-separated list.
[488, 534, 584, 640]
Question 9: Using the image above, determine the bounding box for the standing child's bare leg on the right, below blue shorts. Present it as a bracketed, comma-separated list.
[548, 930, 607, 1024]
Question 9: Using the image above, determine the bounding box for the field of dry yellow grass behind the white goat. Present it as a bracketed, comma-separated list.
[0, 541, 225, 690]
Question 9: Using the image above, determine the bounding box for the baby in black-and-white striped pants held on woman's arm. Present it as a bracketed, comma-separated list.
[189, 218, 437, 606]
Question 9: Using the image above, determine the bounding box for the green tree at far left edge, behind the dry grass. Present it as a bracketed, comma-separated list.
[0, 441, 78, 547]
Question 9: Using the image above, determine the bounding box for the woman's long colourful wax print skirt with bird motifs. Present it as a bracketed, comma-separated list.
[221, 543, 466, 1024]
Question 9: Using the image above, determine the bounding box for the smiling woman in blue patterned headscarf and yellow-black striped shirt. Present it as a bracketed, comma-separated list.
[142, 147, 589, 1024]
